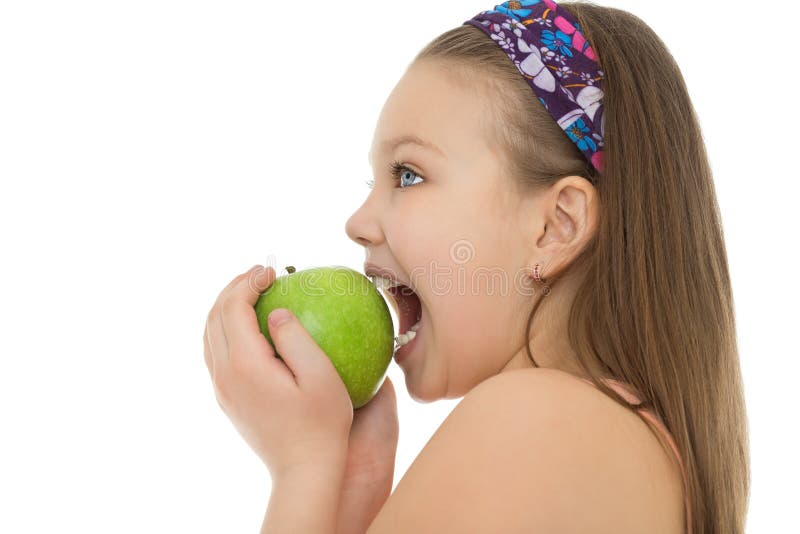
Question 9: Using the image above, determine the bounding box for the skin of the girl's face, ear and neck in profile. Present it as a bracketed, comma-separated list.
[345, 60, 603, 402]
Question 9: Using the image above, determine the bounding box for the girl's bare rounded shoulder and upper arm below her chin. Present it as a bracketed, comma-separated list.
[368, 368, 683, 534]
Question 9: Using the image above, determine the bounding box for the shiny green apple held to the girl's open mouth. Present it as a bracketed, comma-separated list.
[255, 265, 394, 409]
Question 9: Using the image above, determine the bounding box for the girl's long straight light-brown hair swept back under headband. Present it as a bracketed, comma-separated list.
[414, 2, 750, 534]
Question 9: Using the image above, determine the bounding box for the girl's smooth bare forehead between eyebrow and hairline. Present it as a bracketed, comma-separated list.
[367, 63, 484, 163]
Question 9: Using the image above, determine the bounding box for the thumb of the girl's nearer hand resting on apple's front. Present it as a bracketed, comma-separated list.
[267, 308, 341, 391]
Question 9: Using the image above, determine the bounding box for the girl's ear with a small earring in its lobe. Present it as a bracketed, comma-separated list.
[530, 176, 600, 279]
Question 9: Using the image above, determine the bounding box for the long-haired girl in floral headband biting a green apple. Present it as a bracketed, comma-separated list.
[205, 0, 749, 534]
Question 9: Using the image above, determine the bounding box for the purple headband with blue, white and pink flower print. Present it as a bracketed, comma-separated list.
[464, 0, 605, 175]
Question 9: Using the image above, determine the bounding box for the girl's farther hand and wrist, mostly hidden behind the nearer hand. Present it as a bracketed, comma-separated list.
[336, 376, 400, 534]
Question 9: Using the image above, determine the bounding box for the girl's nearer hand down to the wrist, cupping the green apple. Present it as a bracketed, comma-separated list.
[203, 266, 353, 480]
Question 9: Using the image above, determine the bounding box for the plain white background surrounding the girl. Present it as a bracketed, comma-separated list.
[0, 0, 800, 533]
